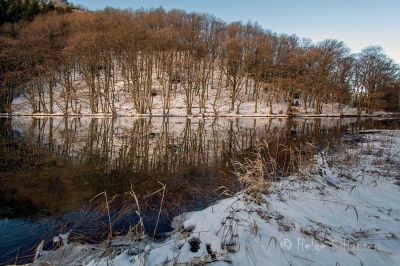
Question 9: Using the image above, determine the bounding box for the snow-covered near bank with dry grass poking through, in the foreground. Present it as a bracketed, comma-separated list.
[36, 131, 400, 265]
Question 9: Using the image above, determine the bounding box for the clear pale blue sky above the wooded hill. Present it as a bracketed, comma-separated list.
[70, 0, 400, 64]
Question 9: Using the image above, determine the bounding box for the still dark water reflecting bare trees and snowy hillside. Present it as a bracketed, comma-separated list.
[0, 117, 400, 264]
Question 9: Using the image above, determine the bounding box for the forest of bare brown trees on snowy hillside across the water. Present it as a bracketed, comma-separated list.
[0, 0, 400, 115]
